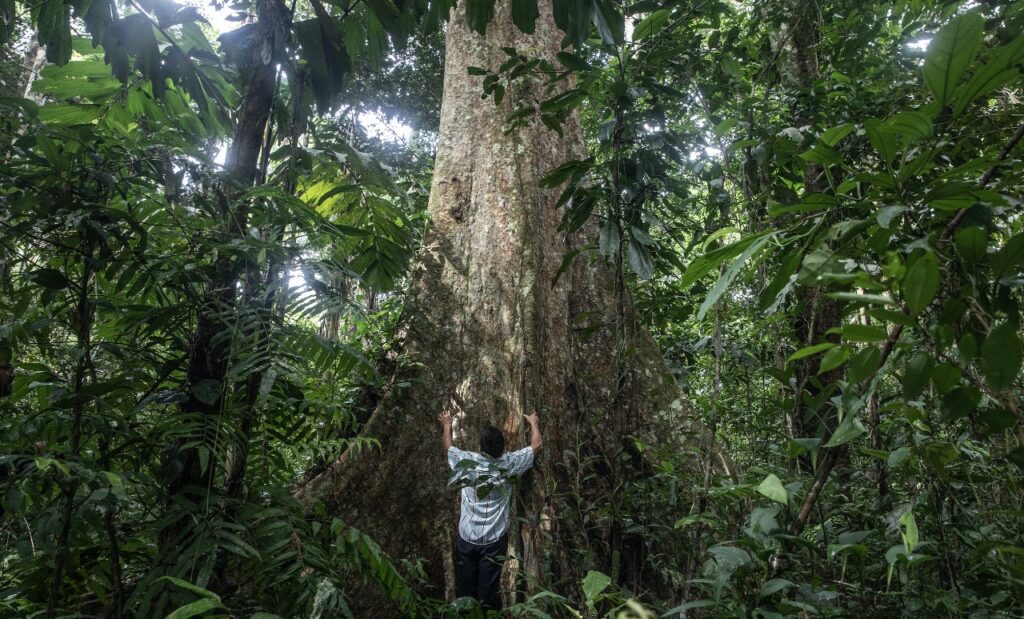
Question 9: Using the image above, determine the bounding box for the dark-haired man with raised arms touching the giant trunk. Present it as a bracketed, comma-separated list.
[437, 403, 542, 612]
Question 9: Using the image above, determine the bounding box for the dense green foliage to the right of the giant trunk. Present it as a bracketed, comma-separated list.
[524, 2, 1024, 616]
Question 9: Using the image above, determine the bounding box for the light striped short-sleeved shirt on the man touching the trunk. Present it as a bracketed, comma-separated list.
[447, 447, 534, 545]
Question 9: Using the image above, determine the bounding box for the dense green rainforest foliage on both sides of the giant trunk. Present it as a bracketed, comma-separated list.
[0, 0, 1024, 617]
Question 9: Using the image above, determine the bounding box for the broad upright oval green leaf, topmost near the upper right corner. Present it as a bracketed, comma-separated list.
[923, 11, 985, 107]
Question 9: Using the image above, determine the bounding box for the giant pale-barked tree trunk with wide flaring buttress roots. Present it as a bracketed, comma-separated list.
[297, 0, 681, 610]
